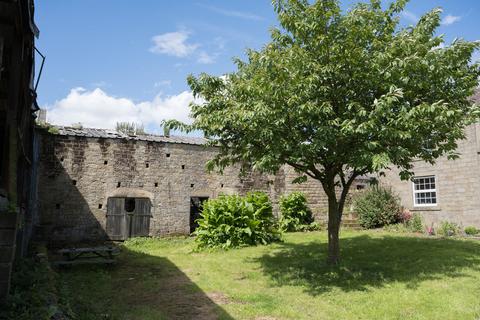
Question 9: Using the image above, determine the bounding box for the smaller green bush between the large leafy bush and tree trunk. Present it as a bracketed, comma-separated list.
[279, 192, 313, 231]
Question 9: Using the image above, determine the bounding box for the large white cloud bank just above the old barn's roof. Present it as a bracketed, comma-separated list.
[45, 88, 200, 129]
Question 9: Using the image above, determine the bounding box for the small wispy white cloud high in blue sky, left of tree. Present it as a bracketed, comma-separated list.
[150, 31, 199, 57]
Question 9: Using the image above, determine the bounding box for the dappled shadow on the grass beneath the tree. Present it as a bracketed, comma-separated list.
[254, 235, 480, 295]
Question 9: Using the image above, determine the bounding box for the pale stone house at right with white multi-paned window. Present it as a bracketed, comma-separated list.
[381, 91, 480, 228]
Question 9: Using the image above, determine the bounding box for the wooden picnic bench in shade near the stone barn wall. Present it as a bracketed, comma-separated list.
[54, 246, 120, 266]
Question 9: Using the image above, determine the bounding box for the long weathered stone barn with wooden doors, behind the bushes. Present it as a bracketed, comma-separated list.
[38, 127, 362, 243]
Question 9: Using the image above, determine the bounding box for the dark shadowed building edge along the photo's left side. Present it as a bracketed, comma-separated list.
[0, 0, 39, 300]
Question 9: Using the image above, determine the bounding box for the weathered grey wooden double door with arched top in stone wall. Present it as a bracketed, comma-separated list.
[106, 197, 151, 240]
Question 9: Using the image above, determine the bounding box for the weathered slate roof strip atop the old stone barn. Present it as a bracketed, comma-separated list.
[51, 126, 207, 145]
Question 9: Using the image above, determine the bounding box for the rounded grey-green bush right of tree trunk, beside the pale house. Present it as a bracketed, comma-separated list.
[353, 185, 401, 229]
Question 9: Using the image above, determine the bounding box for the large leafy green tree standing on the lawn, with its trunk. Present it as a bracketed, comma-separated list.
[163, 0, 480, 264]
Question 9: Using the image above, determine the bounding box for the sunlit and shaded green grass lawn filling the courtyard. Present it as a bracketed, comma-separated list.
[60, 231, 480, 320]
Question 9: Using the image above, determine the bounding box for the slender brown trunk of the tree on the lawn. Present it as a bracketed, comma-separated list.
[327, 192, 341, 265]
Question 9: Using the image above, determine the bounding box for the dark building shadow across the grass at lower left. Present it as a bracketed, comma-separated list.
[60, 247, 233, 320]
